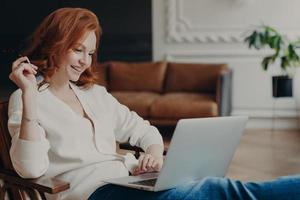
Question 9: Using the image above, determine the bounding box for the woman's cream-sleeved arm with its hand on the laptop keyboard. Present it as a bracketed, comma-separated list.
[102, 88, 164, 175]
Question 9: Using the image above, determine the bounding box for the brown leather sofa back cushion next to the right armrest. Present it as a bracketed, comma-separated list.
[165, 63, 228, 93]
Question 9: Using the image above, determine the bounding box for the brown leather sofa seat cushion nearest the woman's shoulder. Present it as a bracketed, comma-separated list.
[111, 92, 159, 118]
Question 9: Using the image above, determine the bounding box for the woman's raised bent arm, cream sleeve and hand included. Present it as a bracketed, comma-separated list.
[8, 57, 49, 178]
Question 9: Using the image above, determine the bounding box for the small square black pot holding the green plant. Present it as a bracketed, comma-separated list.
[272, 76, 293, 97]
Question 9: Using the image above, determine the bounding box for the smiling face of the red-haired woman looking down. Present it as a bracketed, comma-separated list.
[58, 31, 97, 81]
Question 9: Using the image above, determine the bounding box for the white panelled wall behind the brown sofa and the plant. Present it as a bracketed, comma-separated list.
[152, 0, 300, 128]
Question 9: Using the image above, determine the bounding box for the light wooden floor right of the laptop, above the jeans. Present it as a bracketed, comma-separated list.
[226, 130, 300, 181]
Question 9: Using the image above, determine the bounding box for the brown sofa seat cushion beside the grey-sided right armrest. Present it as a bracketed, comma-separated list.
[150, 92, 218, 119]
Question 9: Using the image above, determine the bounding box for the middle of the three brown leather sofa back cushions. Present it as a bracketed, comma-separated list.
[109, 62, 167, 92]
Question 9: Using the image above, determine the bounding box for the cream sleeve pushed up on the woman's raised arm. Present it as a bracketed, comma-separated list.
[8, 90, 50, 178]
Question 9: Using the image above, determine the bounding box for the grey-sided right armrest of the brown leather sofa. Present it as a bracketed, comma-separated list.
[216, 69, 232, 116]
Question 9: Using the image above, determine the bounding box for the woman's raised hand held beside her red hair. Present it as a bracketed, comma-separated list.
[9, 56, 38, 91]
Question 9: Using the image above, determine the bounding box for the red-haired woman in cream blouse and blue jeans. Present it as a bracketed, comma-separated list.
[8, 8, 300, 200]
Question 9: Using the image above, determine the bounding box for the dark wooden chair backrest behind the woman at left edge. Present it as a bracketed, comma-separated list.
[0, 101, 14, 170]
